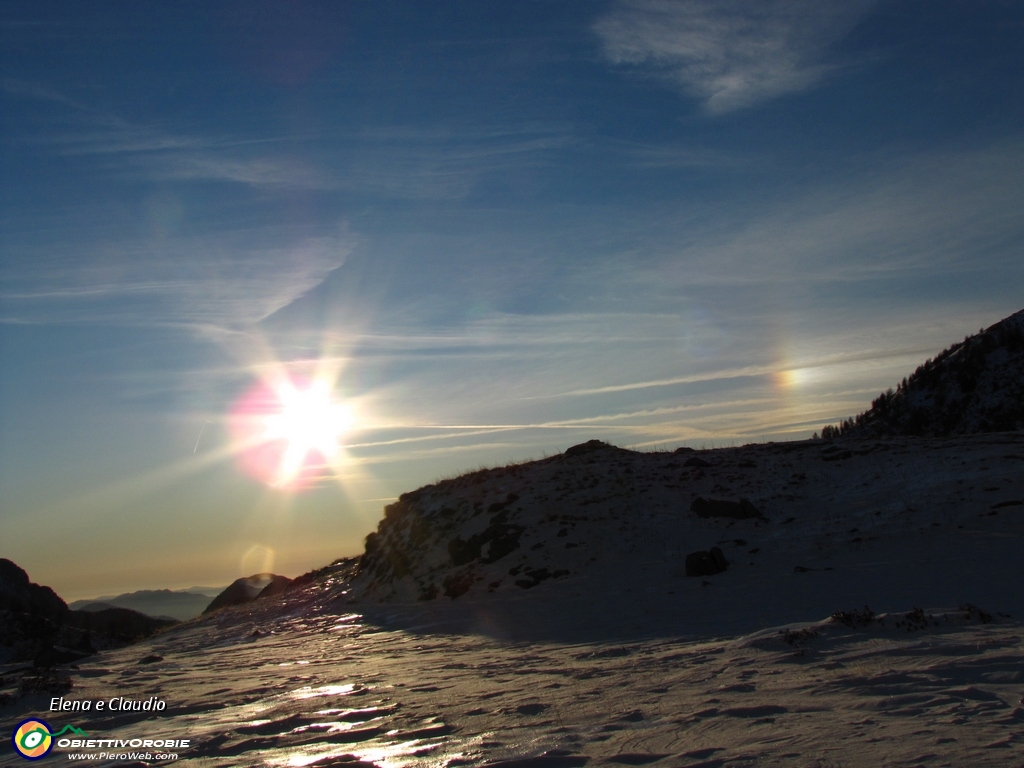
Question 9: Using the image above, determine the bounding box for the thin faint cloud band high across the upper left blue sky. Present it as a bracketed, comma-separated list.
[0, 78, 569, 195]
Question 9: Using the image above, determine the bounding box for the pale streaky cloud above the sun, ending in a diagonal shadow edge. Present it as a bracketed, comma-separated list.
[0, 227, 352, 328]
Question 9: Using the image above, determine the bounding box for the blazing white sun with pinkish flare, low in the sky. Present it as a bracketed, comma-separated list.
[231, 377, 352, 488]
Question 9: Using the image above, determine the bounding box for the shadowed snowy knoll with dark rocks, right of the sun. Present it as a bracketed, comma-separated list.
[351, 433, 1024, 623]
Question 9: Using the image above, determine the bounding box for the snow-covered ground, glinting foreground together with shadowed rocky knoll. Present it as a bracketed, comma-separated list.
[0, 433, 1024, 768]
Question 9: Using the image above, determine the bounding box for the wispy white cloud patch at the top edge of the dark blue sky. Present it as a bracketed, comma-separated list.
[594, 0, 873, 114]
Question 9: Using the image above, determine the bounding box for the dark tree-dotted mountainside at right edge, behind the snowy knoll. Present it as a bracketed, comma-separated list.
[821, 310, 1024, 437]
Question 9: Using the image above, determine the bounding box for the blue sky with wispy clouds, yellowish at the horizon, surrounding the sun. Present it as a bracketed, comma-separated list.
[0, 0, 1024, 598]
